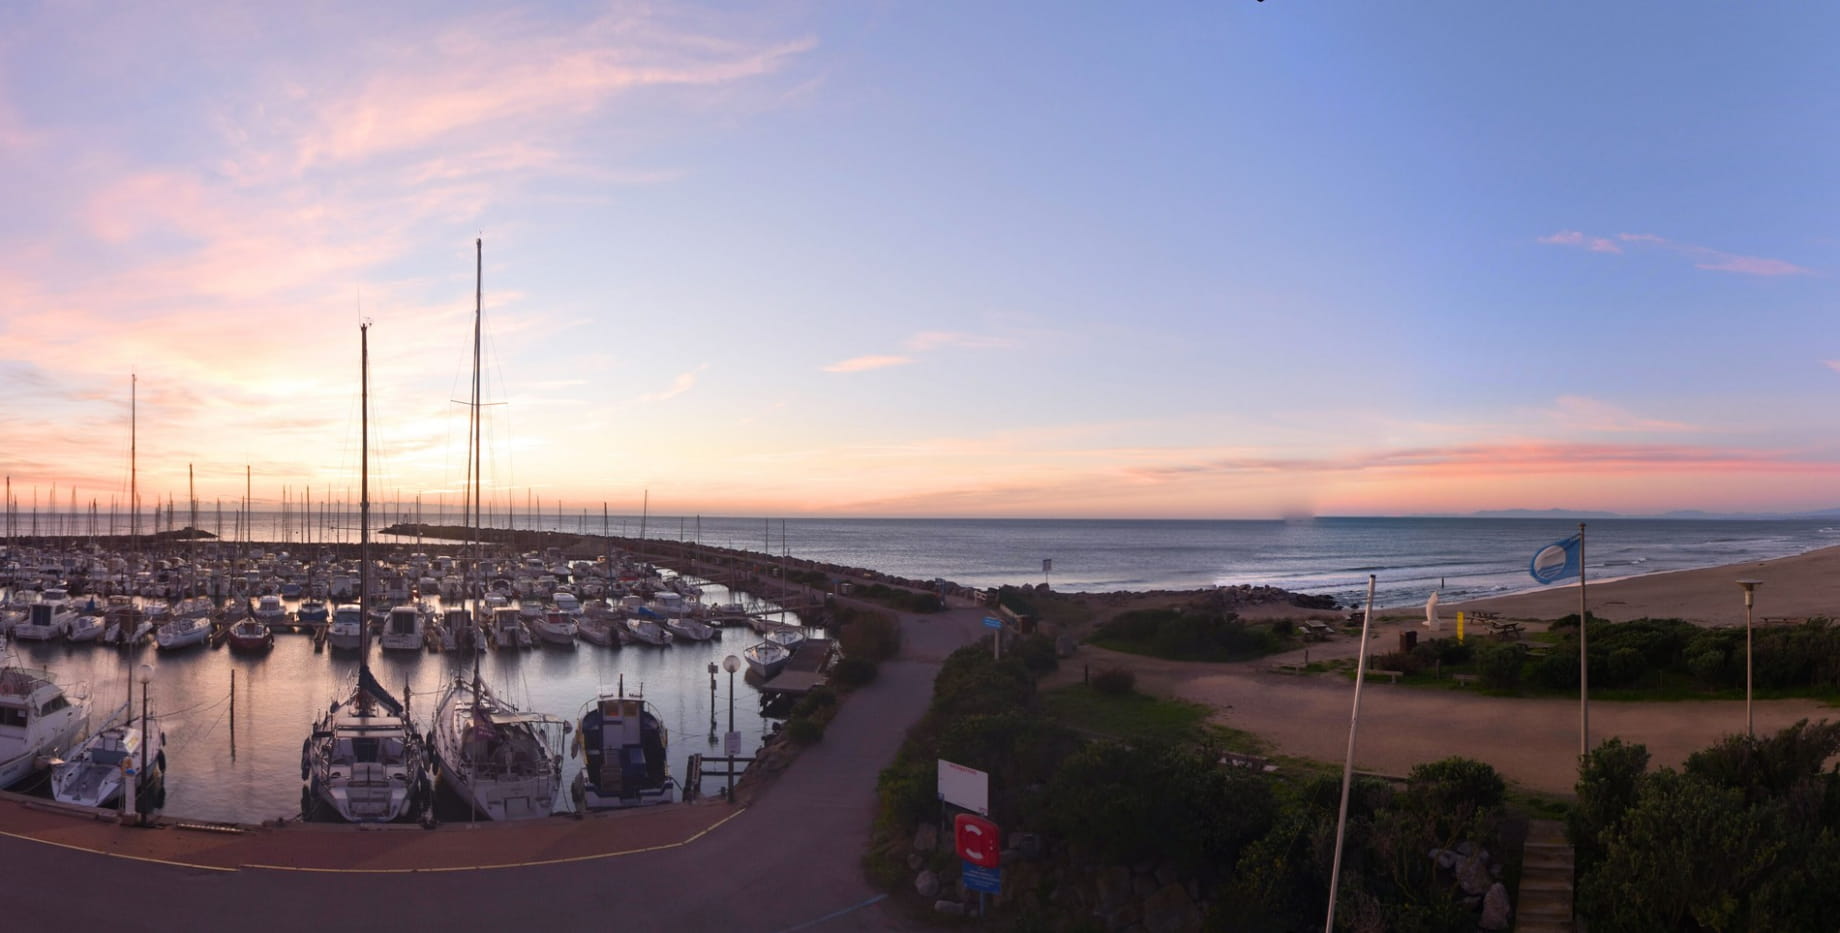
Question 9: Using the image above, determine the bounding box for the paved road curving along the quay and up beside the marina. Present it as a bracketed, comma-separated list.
[0, 609, 983, 933]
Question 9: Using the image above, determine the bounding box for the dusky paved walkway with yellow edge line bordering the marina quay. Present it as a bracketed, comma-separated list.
[0, 609, 983, 933]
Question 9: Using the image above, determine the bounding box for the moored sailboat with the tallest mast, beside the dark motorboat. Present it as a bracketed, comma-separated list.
[432, 241, 569, 819]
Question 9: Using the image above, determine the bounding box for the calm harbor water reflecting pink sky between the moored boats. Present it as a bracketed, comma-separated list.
[9, 587, 799, 823]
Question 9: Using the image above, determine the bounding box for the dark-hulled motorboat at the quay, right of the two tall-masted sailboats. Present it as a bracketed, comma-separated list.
[570, 696, 677, 810]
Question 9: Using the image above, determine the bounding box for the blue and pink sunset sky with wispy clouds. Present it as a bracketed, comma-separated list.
[0, 0, 1840, 519]
